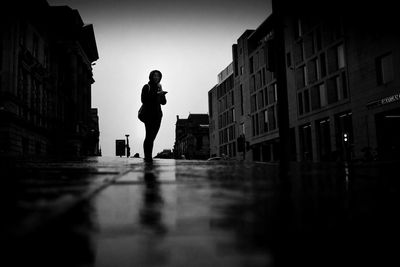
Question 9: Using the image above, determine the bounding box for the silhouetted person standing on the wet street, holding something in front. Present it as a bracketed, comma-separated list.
[141, 70, 167, 162]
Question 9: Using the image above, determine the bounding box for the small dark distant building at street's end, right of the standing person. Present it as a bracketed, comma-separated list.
[174, 114, 210, 159]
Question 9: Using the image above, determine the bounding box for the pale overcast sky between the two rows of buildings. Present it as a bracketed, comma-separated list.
[48, 0, 271, 157]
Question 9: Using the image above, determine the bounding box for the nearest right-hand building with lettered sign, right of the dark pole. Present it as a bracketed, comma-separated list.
[285, 7, 400, 162]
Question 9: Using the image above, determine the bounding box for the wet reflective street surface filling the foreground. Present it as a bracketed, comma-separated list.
[0, 157, 400, 267]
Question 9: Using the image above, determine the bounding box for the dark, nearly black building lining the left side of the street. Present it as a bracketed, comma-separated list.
[0, 0, 98, 156]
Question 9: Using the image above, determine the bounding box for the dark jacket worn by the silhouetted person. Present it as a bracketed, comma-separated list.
[141, 82, 167, 120]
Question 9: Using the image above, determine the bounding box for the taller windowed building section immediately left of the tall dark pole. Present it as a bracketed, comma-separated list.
[238, 16, 279, 161]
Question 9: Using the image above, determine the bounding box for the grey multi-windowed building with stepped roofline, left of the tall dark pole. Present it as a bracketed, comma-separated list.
[209, 19, 279, 161]
